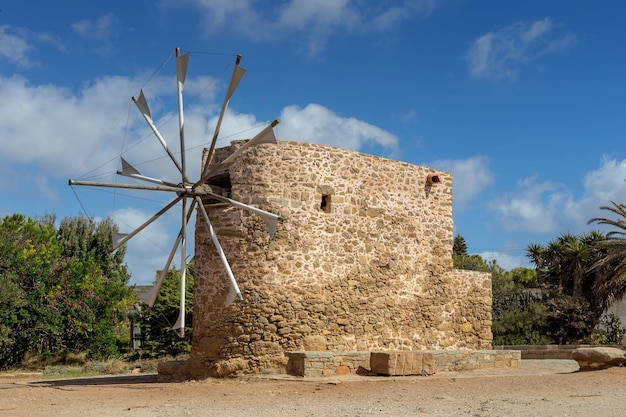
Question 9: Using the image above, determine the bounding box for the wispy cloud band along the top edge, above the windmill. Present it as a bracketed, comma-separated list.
[161, 0, 436, 56]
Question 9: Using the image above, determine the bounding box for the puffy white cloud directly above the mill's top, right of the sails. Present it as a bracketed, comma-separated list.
[277, 103, 398, 153]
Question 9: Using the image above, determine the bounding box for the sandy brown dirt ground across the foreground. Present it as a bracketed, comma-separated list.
[0, 360, 626, 417]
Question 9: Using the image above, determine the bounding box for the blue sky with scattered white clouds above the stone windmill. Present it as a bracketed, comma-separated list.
[0, 0, 626, 284]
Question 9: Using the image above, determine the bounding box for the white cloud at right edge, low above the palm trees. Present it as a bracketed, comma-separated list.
[489, 157, 626, 233]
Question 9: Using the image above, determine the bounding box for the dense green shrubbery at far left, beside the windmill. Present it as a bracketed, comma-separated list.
[0, 214, 132, 367]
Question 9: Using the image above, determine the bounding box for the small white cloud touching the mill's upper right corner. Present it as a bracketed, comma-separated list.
[426, 156, 494, 211]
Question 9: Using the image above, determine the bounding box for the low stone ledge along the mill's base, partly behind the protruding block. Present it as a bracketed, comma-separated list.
[287, 349, 522, 377]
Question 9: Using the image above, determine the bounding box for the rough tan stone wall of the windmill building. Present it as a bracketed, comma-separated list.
[187, 142, 492, 377]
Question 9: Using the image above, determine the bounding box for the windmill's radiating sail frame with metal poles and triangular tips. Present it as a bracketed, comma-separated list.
[68, 48, 282, 337]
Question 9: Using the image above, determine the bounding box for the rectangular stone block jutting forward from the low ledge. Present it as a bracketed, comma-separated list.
[370, 351, 436, 376]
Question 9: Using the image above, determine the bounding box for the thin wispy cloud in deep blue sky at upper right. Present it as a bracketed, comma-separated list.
[465, 18, 576, 80]
